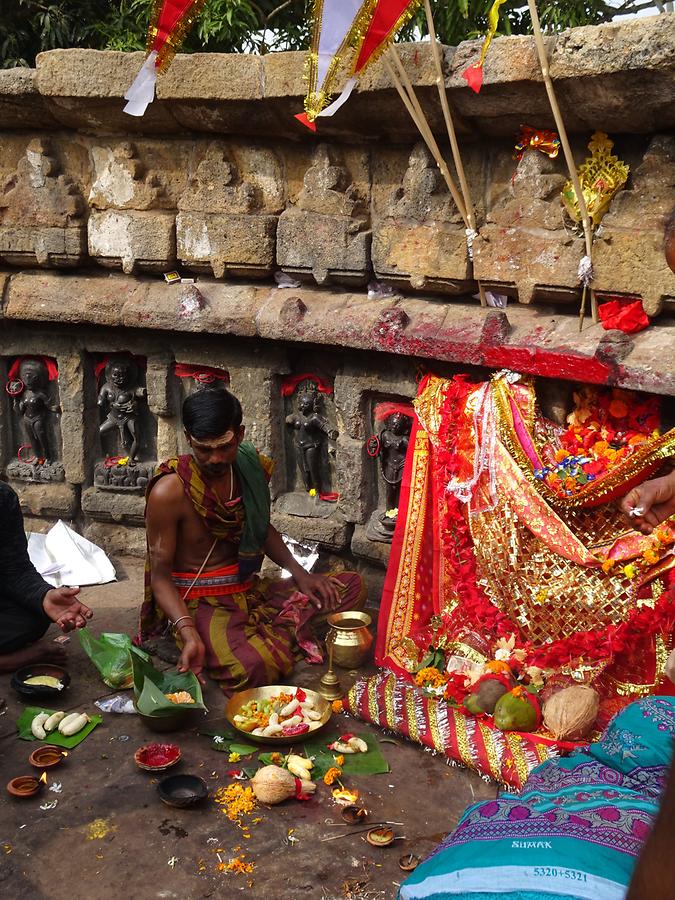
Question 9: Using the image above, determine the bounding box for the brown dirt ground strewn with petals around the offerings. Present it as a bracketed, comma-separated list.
[0, 560, 496, 900]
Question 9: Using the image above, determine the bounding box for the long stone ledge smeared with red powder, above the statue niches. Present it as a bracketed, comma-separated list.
[4, 272, 675, 394]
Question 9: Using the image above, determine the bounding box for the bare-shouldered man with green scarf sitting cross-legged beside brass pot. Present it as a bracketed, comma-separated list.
[139, 389, 365, 694]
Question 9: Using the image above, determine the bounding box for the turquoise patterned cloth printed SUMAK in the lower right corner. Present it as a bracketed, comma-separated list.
[399, 697, 675, 900]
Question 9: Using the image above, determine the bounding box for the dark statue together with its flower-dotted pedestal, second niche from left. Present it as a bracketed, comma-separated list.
[94, 353, 155, 491]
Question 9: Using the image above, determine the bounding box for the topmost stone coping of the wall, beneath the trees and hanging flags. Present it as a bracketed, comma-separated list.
[0, 13, 664, 135]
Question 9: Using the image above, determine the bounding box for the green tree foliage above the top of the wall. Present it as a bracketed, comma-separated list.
[0, 0, 662, 68]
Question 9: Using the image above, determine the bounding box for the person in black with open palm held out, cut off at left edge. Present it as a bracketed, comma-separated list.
[0, 481, 93, 672]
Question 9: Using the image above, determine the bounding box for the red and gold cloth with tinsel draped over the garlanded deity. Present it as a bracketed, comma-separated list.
[376, 373, 675, 703]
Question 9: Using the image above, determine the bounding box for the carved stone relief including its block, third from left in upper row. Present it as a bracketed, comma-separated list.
[176, 142, 284, 278]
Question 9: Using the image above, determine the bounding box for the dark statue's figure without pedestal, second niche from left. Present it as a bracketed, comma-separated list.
[98, 359, 147, 462]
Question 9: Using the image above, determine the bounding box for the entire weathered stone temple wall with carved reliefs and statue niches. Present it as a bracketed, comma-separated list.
[0, 14, 675, 588]
